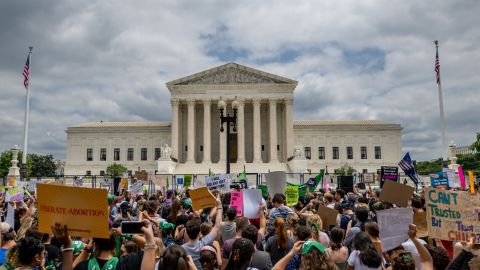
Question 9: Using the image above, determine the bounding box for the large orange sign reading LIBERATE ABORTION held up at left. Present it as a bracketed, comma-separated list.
[37, 184, 110, 238]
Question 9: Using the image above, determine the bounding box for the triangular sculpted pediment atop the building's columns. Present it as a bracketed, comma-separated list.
[167, 63, 298, 86]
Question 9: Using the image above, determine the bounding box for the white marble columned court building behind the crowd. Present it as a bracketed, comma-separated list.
[65, 63, 402, 175]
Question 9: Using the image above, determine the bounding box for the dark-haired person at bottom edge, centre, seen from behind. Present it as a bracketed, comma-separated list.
[225, 238, 257, 270]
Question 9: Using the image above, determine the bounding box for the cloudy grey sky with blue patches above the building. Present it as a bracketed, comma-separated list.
[0, 0, 480, 160]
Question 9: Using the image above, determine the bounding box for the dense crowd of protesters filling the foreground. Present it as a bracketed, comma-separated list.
[0, 182, 480, 270]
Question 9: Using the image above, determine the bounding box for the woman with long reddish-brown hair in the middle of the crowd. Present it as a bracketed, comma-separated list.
[265, 218, 293, 264]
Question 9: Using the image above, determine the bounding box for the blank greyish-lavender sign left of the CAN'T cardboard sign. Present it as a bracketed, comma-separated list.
[377, 208, 413, 252]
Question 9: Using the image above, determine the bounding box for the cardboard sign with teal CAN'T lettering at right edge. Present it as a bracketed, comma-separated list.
[425, 188, 480, 243]
